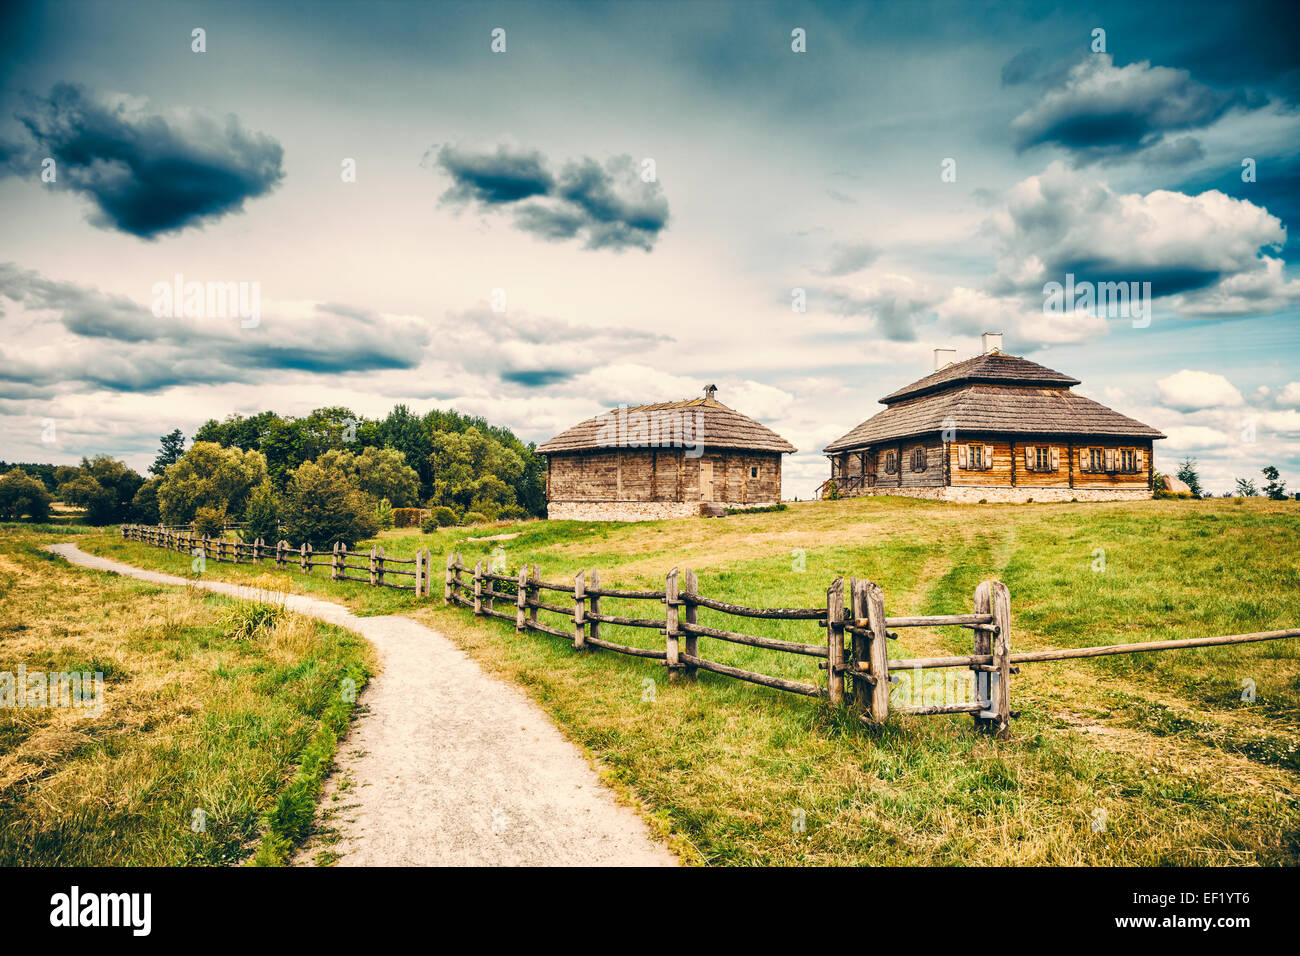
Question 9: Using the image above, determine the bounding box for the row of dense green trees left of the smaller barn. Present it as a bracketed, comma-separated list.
[0, 405, 546, 546]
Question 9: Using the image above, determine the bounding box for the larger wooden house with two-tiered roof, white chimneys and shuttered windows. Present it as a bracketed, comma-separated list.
[819, 332, 1165, 501]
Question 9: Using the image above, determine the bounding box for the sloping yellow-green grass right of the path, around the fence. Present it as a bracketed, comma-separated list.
[58, 498, 1300, 865]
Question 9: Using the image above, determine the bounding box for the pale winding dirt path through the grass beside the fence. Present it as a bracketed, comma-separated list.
[48, 544, 676, 866]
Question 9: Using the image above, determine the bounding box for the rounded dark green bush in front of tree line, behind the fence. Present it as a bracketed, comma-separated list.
[281, 462, 378, 550]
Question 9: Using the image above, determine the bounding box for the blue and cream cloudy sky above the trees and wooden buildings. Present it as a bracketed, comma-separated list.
[0, 0, 1300, 498]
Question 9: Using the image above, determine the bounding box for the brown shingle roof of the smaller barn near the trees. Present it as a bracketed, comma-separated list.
[537, 398, 796, 455]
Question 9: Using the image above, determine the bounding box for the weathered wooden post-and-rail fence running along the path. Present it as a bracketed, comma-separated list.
[122, 525, 1300, 734]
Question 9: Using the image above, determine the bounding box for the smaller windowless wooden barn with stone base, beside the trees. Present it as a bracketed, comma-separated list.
[537, 385, 794, 522]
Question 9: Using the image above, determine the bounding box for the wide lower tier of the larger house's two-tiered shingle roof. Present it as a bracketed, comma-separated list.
[826, 382, 1165, 453]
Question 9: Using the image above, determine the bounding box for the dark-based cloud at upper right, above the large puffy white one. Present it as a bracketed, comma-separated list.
[1009, 53, 1242, 163]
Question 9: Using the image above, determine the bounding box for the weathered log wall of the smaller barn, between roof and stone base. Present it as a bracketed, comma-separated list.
[546, 449, 781, 505]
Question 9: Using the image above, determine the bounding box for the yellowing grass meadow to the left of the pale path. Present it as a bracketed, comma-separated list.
[0, 525, 373, 866]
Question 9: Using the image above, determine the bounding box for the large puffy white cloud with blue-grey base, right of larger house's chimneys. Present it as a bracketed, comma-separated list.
[988, 163, 1294, 311]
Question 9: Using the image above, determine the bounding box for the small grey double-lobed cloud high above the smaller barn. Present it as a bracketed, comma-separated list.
[436, 144, 668, 252]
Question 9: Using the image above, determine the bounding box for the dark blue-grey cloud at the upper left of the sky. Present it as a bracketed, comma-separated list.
[5, 83, 285, 239]
